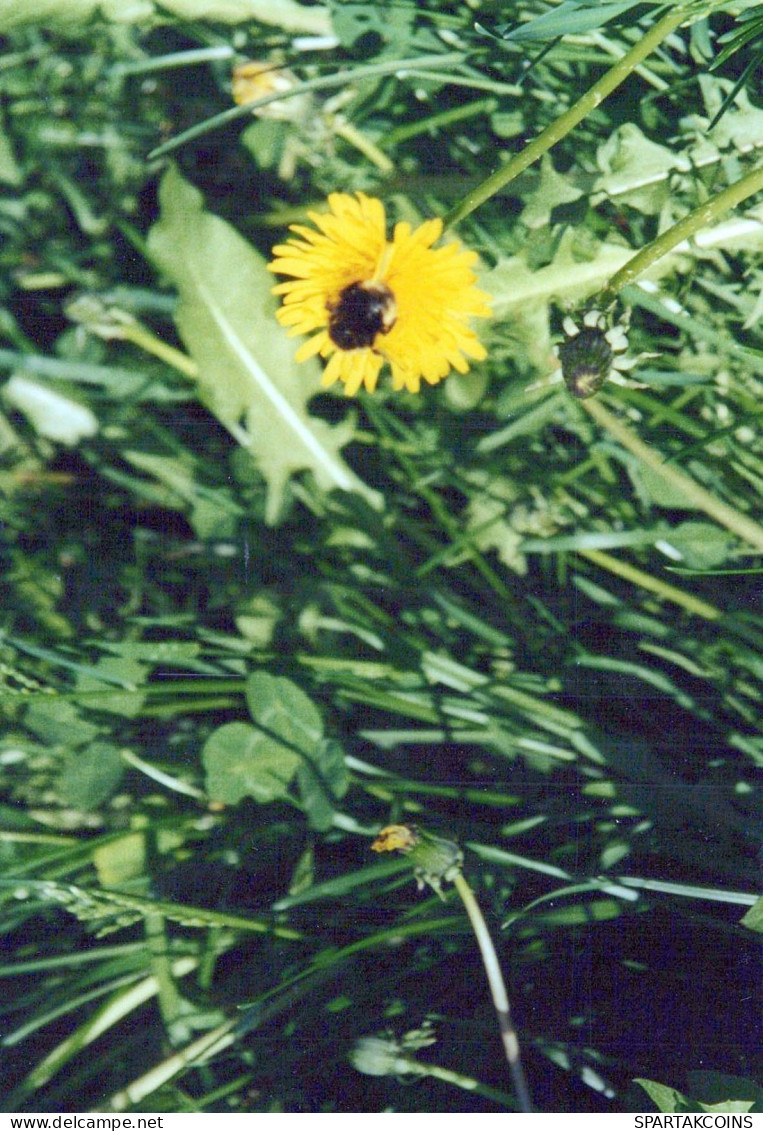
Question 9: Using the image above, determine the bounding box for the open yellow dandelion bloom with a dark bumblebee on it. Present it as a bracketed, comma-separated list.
[268, 192, 489, 396]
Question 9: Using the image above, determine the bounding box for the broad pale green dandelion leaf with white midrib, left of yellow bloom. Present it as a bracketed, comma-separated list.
[148, 167, 378, 524]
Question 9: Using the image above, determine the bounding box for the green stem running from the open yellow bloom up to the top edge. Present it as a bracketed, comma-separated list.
[443, 5, 687, 228]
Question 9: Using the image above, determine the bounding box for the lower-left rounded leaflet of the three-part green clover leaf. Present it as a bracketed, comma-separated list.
[201, 723, 301, 805]
